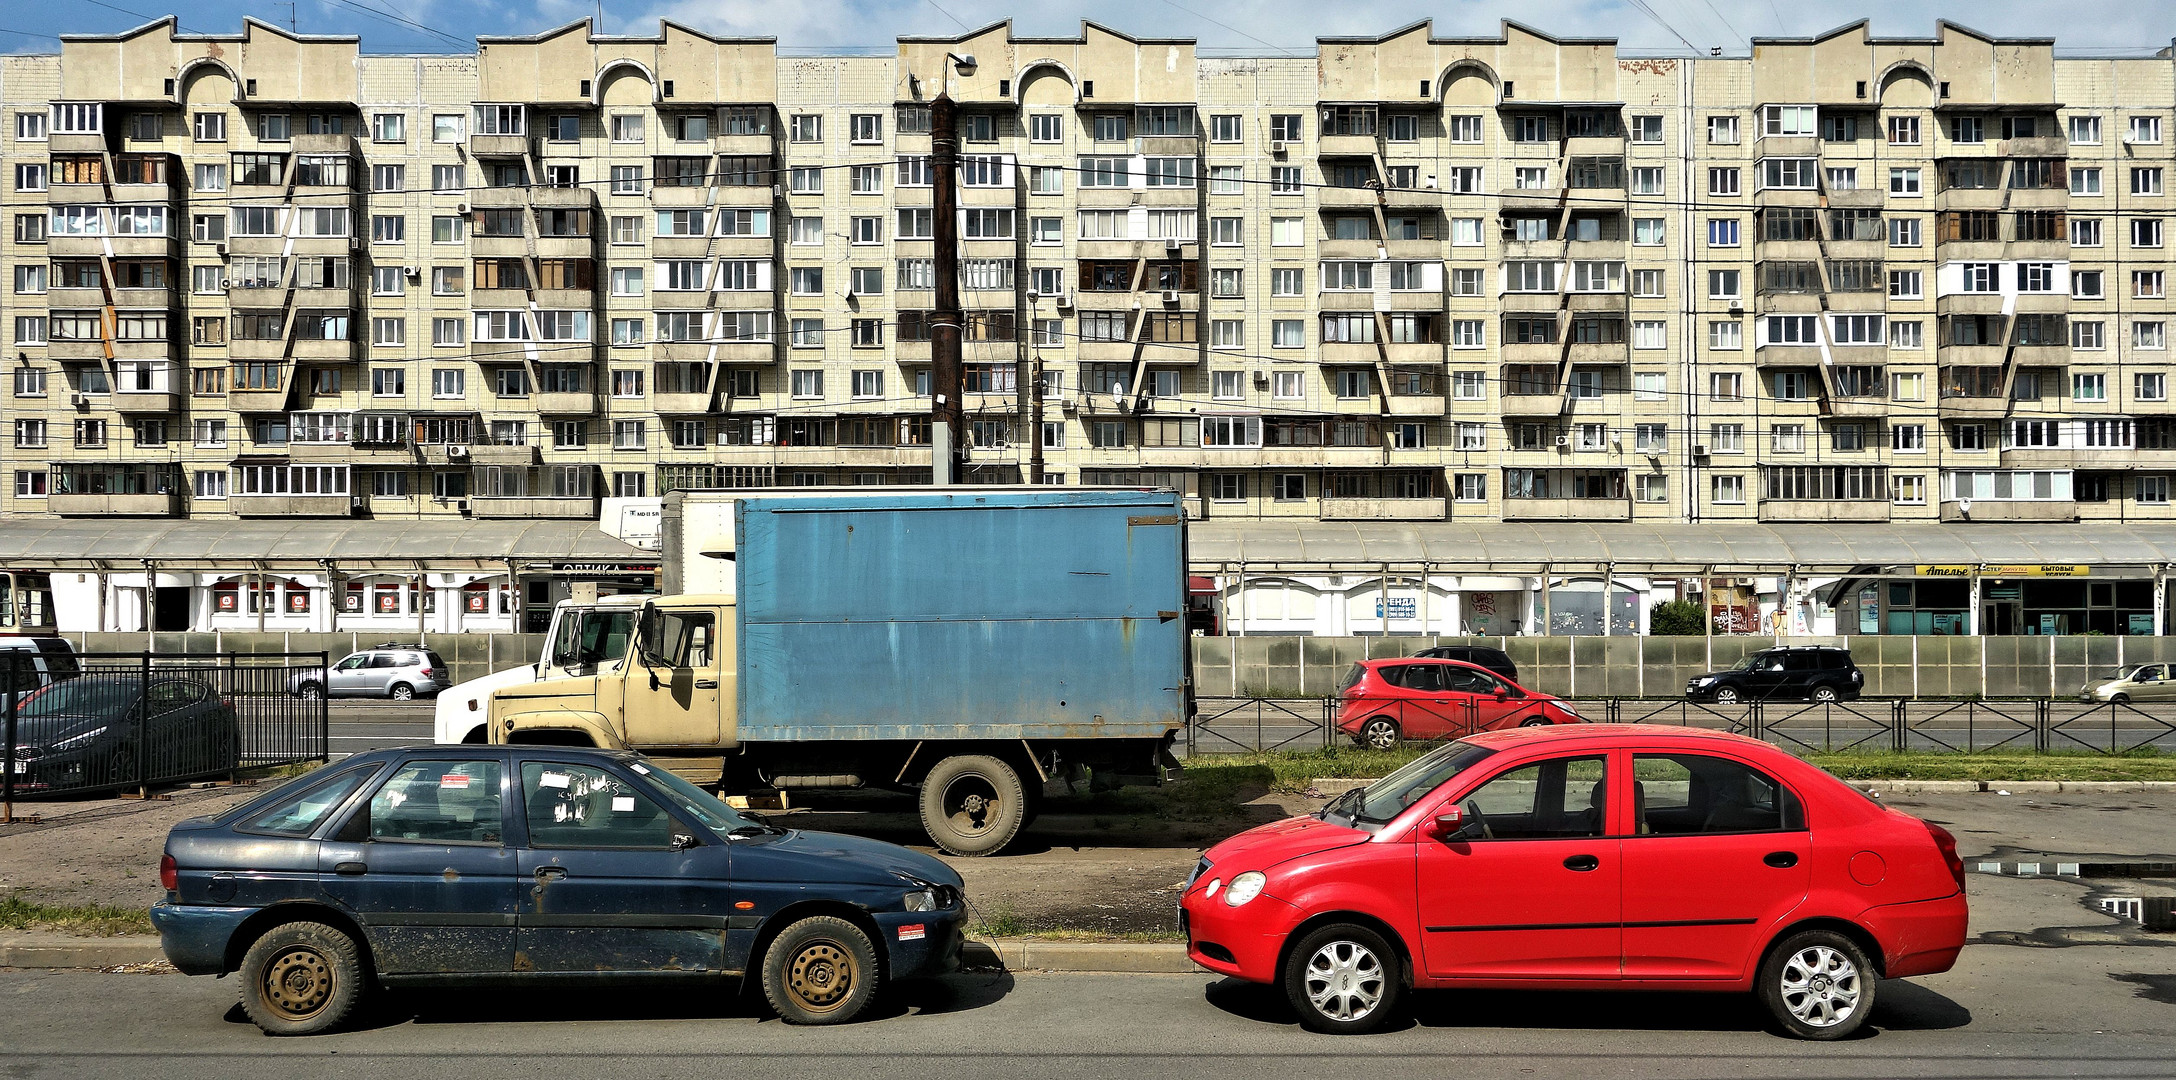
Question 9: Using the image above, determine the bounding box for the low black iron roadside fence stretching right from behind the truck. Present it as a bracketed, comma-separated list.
[1186, 697, 2176, 753]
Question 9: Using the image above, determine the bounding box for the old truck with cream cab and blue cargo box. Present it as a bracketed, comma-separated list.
[490, 488, 1192, 856]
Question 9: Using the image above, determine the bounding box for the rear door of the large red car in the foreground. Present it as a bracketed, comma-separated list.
[1623, 753, 1813, 980]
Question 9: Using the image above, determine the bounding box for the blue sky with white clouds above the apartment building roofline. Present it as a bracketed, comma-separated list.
[0, 0, 2176, 54]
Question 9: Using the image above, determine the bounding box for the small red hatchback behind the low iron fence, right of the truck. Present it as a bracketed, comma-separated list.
[1338, 658, 1580, 749]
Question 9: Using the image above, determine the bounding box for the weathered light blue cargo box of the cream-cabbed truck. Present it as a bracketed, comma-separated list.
[731, 488, 1188, 743]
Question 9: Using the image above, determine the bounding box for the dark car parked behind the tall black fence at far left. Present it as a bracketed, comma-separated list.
[13, 673, 242, 793]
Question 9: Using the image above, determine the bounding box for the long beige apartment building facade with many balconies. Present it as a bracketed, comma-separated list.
[0, 20, 2176, 535]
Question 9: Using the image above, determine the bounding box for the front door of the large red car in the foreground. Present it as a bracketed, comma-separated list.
[1414, 753, 1623, 980]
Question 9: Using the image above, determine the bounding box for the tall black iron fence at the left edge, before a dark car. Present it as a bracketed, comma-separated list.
[0, 651, 329, 801]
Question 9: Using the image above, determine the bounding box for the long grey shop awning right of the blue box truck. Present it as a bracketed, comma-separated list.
[1186, 520, 2176, 575]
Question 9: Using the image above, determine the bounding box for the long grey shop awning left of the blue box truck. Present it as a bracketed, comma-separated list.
[0, 518, 657, 573]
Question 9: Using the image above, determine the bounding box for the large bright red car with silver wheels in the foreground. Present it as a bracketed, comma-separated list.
[1179, 725, 1965, 1039]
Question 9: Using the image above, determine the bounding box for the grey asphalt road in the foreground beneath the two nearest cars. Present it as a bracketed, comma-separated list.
[0, 918, 2176, 1080]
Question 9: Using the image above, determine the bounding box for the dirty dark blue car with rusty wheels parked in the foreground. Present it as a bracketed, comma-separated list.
[150, 745, 964, 1034]
